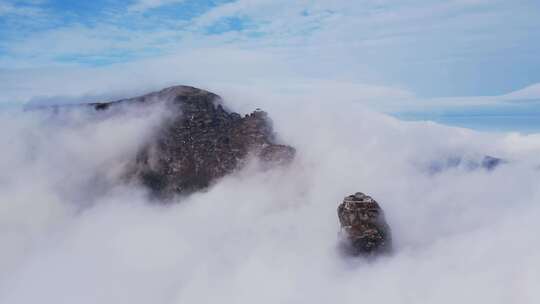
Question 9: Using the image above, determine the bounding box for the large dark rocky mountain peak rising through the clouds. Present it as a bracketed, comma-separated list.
[91, 86, 295, 197]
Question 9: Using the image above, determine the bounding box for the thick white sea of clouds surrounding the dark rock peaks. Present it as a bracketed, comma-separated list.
[0, 86, 540, 304]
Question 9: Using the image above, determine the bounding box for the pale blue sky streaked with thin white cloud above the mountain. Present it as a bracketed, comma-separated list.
[0, 0, 540, 126]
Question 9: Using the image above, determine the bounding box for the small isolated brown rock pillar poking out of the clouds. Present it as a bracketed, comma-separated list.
[337, 192, 392, 255]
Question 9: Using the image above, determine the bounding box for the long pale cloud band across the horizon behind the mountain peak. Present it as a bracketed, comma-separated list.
[4, 44, 538, 116]
